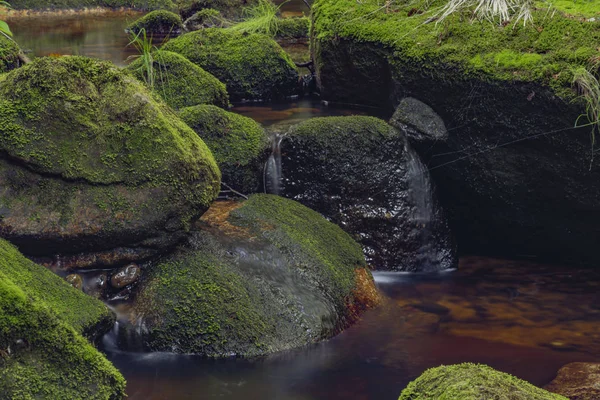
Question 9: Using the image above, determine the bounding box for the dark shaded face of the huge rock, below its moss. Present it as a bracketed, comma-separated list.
[314, 36, 600, 264]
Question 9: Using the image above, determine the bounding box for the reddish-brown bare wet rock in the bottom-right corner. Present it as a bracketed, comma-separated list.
[544, 362, 600, 400]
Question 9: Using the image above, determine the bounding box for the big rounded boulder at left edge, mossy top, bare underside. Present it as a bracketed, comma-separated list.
[0, 57, 220, 264]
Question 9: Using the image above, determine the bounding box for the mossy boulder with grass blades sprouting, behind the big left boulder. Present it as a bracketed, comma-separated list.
[127, 50, 229, 109]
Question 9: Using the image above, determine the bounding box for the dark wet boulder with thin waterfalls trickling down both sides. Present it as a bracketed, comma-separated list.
[280, 117, 456, 271]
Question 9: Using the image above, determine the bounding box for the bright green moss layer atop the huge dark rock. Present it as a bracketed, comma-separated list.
[313, 0, 600, 99]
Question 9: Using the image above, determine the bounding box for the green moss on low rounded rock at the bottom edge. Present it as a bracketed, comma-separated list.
[399, 363, 566, 400]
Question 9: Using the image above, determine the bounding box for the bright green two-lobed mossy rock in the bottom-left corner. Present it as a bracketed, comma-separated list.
[0, 239, 125, 400]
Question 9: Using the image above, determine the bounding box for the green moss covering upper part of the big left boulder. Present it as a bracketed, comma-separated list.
[0, 57, 218, 197]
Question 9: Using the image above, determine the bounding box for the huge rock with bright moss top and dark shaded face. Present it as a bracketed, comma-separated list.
[312, 0, 600, 265]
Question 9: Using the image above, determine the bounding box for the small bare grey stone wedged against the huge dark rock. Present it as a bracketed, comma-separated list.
[390, 97, 448, 144]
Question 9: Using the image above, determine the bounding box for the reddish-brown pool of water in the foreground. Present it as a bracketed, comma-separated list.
[103, 257, 600, 400]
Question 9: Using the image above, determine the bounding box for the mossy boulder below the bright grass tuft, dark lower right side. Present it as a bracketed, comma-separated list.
[163, 28, 298, 101]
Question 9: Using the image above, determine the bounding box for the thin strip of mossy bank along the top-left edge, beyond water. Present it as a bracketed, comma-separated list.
[10, 0, 177, 11]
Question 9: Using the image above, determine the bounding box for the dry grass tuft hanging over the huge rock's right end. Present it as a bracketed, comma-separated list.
[573, 67, 600, 170]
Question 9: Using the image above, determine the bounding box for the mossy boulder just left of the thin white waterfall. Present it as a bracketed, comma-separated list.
[179, 105, 269, 193]
